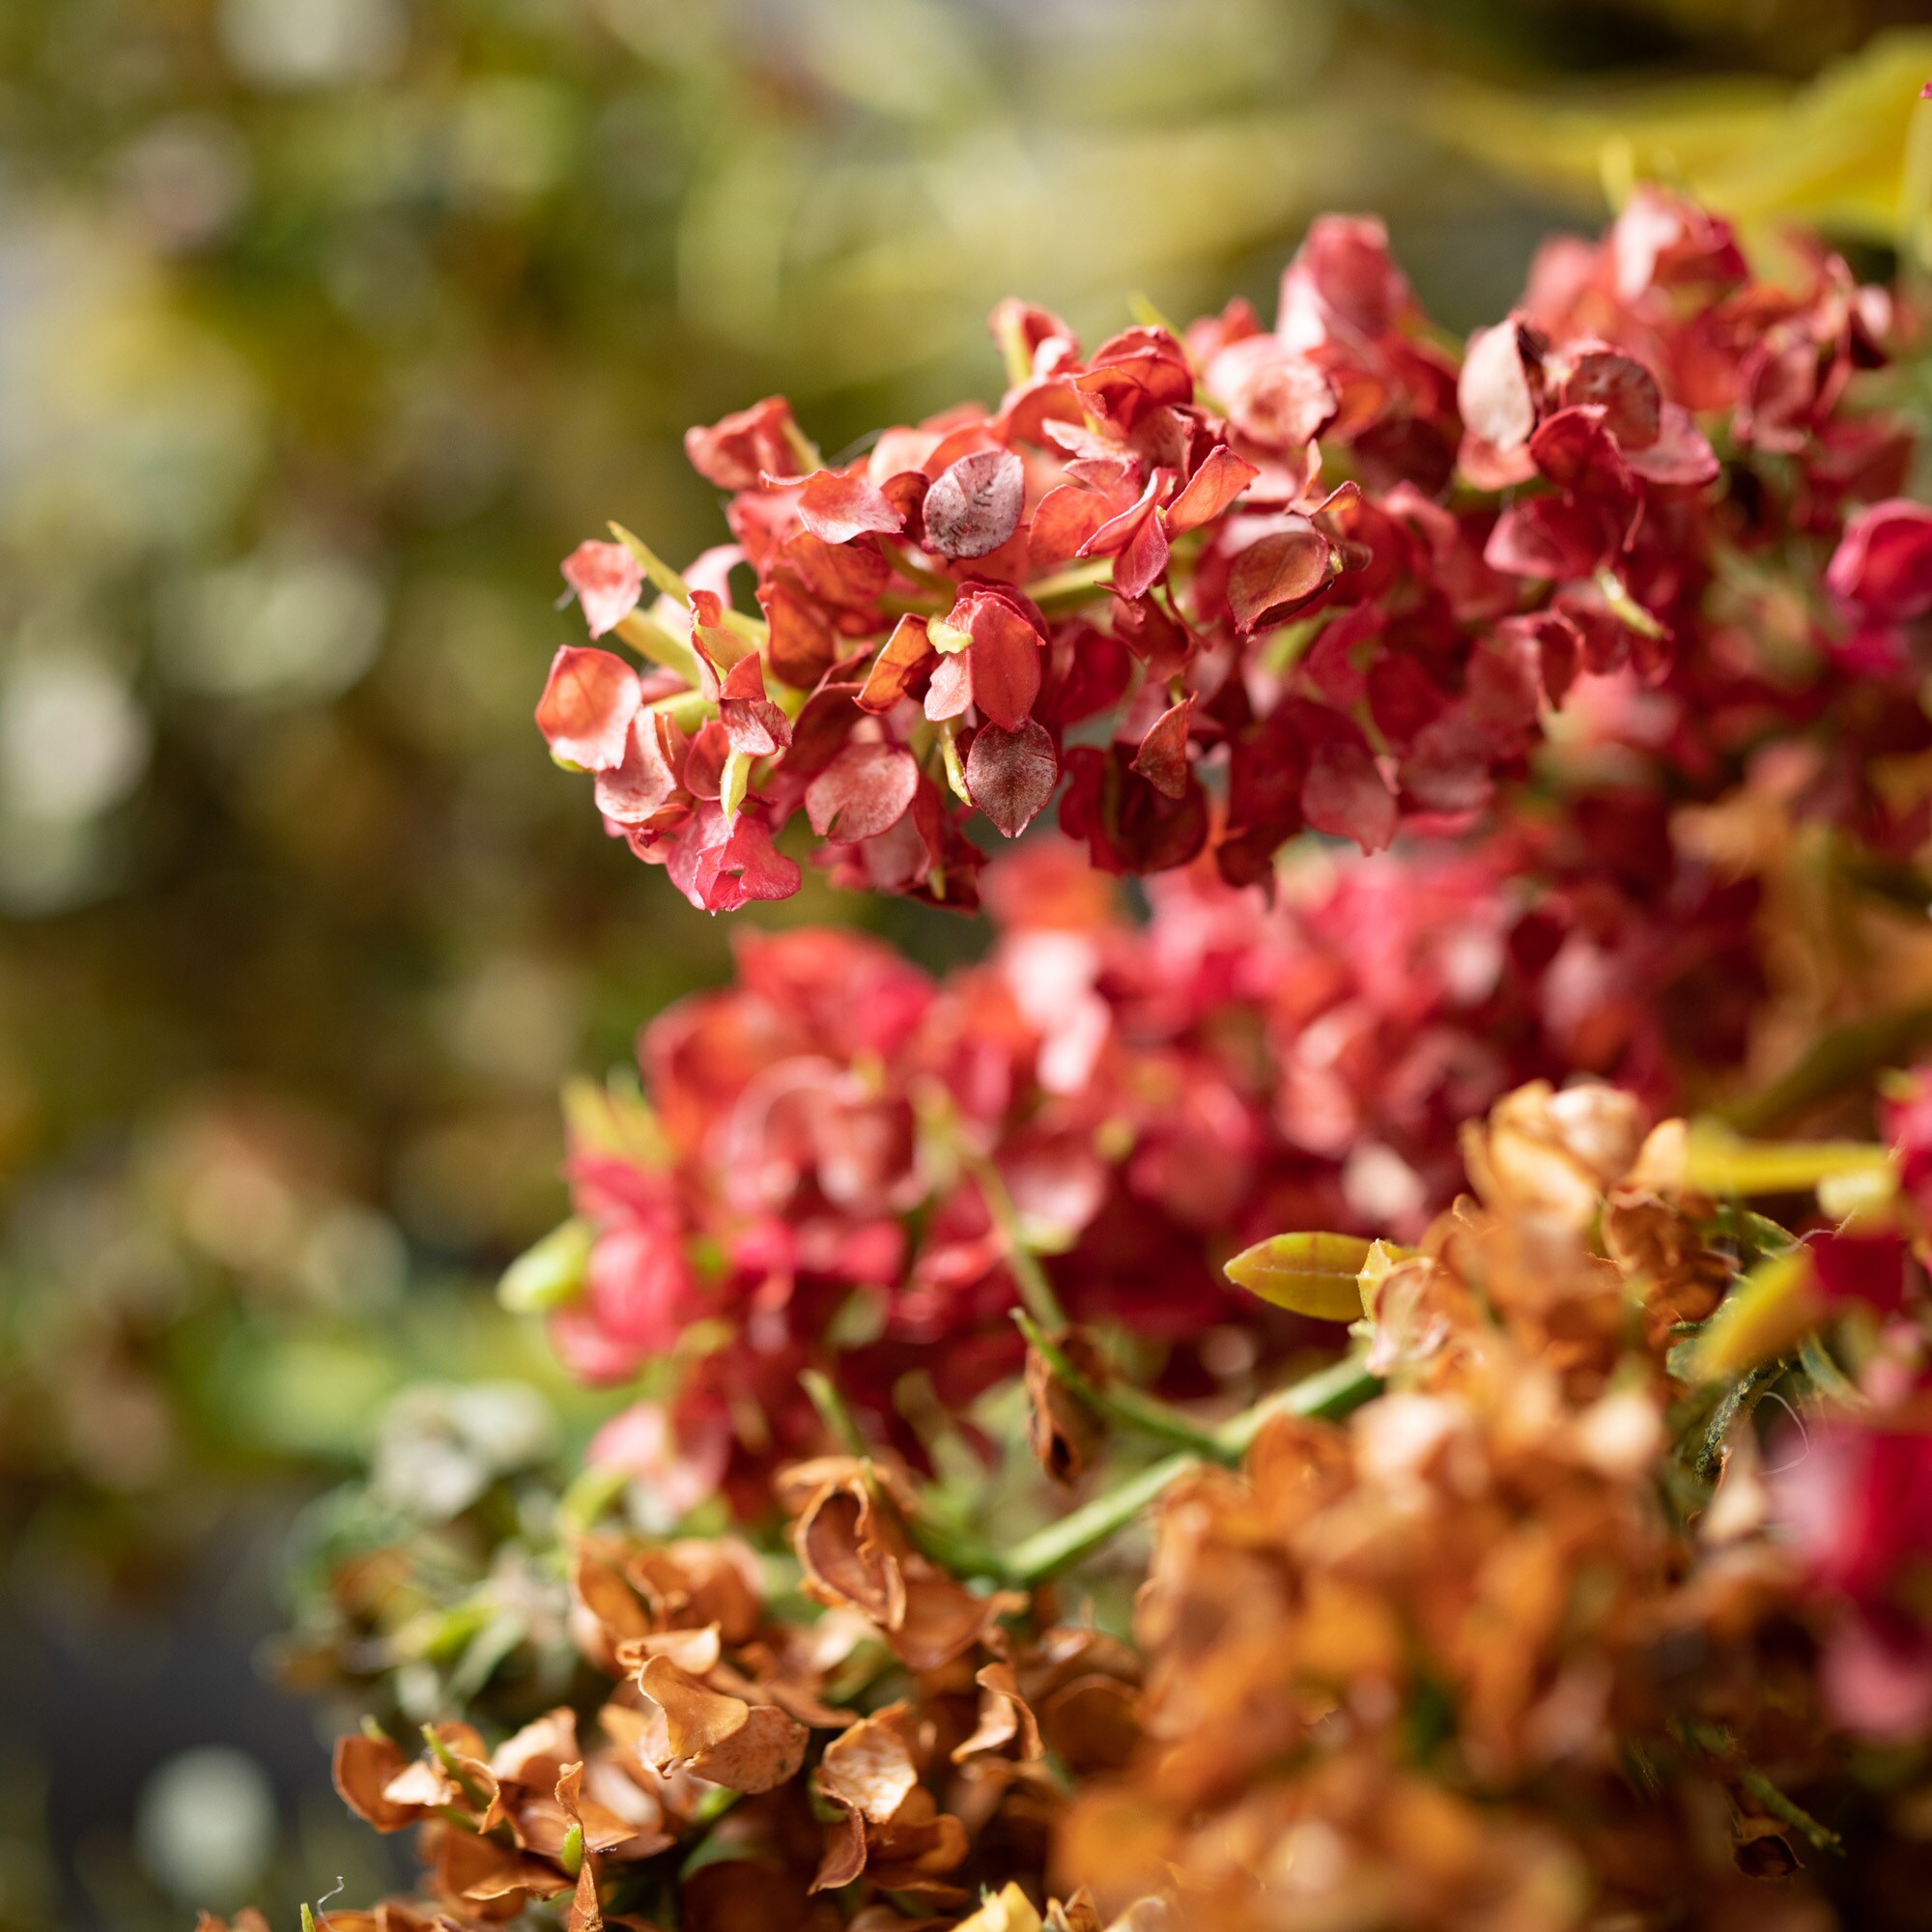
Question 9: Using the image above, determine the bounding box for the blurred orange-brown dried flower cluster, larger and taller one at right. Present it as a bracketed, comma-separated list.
[1061, 1086, 1833, 1932]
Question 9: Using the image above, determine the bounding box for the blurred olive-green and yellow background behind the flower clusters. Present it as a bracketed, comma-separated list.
[0, 0, 1932, 1932]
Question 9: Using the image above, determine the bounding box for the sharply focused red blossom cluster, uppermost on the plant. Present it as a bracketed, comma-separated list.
[537, 189, 1932, 910]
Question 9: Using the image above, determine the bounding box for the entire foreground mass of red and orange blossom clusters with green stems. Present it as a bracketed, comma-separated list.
[226, 178, 1932, 1932]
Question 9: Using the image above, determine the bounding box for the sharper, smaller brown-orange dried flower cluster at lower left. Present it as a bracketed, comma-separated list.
[330, 1457, 1138, 1932]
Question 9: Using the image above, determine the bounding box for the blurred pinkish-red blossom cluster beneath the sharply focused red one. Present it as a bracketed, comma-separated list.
[529, 819, 1748, 1515]
